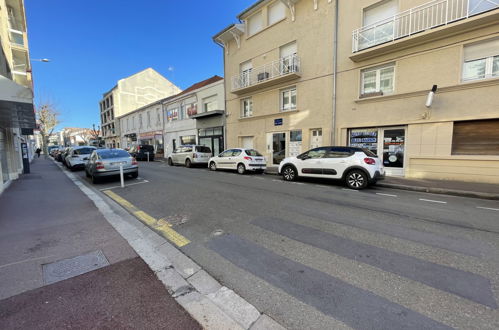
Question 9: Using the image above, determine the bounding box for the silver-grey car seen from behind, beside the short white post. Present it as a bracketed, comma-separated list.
[85, 149, 139, 183]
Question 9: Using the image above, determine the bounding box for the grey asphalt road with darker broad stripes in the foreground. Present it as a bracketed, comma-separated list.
[74, 162, 499, 329]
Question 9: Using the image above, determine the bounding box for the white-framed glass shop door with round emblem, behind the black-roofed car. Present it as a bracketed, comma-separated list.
[378, 127, 405, 176]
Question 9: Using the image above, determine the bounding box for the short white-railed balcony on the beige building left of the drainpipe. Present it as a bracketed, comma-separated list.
[232, 55, 301, 94]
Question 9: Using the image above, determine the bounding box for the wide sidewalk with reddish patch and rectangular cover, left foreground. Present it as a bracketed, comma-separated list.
[0, 157, 200, 329]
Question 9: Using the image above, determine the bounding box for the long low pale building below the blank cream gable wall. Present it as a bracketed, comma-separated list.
[119, 96, 173, 157]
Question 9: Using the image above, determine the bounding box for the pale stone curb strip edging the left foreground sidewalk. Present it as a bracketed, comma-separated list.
[54, 161, 285, 330]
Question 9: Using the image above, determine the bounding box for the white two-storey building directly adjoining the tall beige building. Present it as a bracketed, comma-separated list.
[162, 76, 225, 155]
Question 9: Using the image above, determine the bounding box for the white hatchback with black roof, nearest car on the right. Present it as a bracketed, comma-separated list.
[279, 146, 385, 189]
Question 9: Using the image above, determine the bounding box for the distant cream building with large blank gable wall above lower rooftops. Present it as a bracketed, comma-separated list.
[99, 68, 181, 148]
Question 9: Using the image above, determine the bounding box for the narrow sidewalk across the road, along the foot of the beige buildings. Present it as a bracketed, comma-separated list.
[265, 166, 499, 200]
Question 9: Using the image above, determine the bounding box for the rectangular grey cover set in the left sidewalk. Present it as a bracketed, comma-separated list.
[42, 250, 109, 284]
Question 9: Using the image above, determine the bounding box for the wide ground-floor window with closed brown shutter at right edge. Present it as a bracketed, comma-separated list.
[452, 119, 499, 156]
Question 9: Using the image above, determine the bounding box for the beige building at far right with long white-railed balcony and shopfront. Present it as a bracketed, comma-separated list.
[336, 0, 499, 183]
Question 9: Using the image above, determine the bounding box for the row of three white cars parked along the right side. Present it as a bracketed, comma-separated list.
[167, 145, 385, 189]
